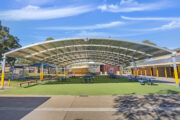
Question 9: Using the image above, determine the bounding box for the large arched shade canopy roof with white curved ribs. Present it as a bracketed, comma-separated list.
[5, 38, 172, 66]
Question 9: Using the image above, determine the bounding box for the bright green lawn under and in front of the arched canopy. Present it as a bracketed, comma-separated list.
[0, 77, 180, 95]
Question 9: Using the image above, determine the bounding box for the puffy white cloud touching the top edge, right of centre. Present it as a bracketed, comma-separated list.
[98, 0, 171, 12]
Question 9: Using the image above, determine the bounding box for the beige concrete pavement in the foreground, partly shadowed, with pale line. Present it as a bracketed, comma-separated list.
[0, 94, 180, 120]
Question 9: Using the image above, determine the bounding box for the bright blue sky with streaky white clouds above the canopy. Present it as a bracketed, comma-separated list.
[0, 0, 180, 49]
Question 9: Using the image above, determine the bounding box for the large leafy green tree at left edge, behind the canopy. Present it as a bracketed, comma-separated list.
[0, 21, 21, 66]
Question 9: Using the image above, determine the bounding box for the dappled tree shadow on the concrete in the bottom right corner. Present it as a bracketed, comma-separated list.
[113, 90, 180, 120]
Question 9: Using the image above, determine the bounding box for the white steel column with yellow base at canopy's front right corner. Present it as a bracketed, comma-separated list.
[172, 52, 180, 87]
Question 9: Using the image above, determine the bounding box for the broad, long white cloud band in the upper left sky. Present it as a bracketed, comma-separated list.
[0, 5, 93, 20]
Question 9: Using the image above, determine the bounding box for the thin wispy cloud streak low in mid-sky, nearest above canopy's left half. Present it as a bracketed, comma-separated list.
[39, 21, 125, 30]
